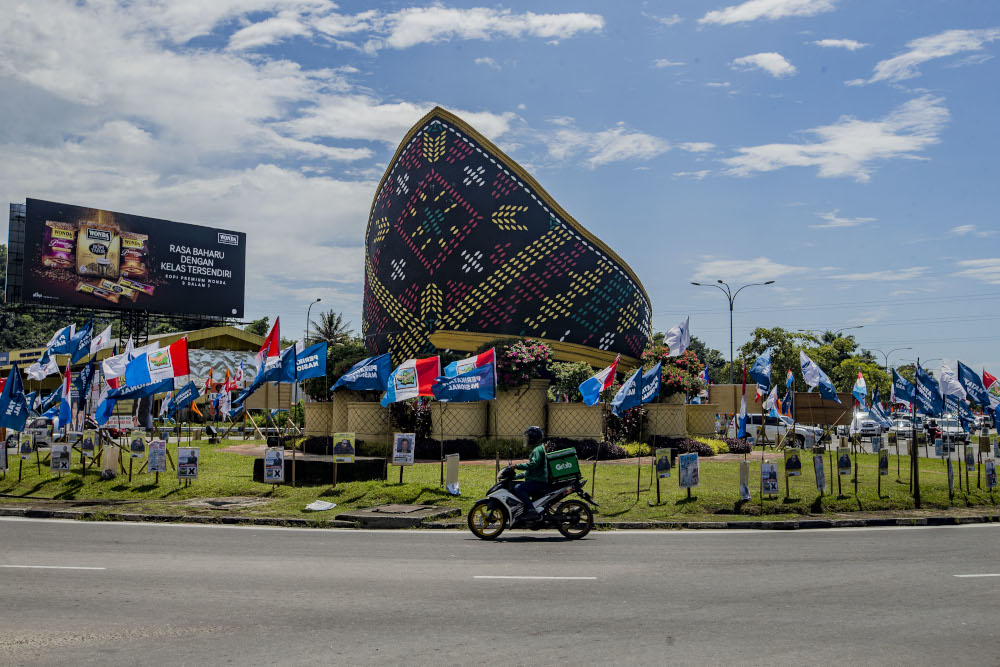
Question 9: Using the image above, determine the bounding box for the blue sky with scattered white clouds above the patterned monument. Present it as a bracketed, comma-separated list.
[0, 0, 1000, 374]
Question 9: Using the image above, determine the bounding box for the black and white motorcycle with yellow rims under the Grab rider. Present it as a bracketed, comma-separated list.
[468, 466, 597, 540]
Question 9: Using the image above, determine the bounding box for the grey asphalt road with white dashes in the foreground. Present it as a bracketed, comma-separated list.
[0, 519, 1000, 665]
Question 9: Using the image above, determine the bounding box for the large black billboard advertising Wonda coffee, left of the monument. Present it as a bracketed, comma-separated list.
[16, 199, 246, 318]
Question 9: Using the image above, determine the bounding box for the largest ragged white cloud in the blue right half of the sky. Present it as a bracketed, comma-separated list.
[723, 95, 949, 182]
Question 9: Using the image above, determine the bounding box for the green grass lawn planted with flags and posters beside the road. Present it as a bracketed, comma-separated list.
[0, 440, 1000, 521]
